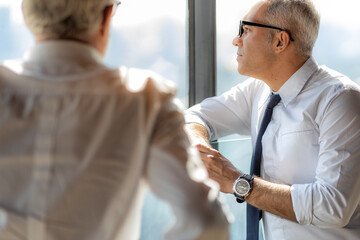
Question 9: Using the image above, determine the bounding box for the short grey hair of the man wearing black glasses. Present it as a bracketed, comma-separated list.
[264, 0, 320, 58]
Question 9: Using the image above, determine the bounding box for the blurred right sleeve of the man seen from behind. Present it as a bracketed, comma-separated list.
[147, 97, 229, 240]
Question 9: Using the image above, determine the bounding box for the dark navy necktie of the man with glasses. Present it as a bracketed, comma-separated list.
[246, 94, 281, 240]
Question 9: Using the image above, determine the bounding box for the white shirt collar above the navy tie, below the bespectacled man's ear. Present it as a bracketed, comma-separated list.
[277, 57, 319, 107]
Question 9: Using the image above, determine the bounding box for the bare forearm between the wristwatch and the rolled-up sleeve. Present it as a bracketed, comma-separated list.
[246, 177, 296, 221]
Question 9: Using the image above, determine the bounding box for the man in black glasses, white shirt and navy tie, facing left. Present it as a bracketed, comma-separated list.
[185, 0, 360, 240]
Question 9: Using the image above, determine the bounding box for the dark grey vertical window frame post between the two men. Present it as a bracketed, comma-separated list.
[187, 0, 216, 106]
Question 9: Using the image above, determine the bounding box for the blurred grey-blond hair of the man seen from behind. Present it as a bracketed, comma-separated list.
[23, 0, 113, 39]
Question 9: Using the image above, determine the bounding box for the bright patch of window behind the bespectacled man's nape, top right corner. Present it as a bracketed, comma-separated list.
[313, 0, 360, 84]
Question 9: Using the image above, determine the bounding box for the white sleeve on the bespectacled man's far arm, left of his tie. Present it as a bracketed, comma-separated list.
[185, 79, 257, 140]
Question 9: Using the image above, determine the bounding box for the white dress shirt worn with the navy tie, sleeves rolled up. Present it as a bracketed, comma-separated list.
[185, 58, 360, 240]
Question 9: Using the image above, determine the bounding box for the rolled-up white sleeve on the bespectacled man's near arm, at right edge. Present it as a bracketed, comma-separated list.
[291, 88, 360, 228]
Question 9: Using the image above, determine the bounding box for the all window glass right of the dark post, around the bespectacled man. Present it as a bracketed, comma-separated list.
[216, 0, 360, 240]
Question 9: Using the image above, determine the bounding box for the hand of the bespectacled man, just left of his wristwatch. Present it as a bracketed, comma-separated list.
[195, 144, 242, 193]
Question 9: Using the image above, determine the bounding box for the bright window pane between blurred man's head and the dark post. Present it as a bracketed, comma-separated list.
[105, 0, 188, 106]
